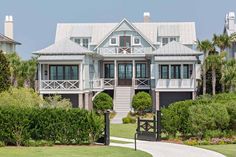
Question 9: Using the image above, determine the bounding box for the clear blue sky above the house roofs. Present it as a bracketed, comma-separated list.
[0, 0, 236, 59]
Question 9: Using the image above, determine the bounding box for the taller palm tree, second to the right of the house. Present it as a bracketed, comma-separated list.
[212, 34, 233, 92]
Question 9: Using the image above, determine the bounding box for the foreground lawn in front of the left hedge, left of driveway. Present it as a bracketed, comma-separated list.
[0, 146, 151, 157]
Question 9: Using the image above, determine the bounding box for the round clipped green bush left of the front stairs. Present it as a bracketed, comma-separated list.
[93, 92, 113, 111]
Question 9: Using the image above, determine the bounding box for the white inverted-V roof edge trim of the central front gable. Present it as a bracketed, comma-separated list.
[95, 18, 156, 49]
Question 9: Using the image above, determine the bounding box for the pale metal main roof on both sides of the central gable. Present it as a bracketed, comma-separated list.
[55, 22, 197, 45]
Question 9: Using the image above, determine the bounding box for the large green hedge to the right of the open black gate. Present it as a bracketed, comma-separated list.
[161, 93, 236, 138]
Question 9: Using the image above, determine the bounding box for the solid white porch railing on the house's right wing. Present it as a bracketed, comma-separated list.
[156, 79, 194, 88]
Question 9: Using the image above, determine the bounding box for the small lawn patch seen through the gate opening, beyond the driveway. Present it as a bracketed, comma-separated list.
[111, 124, 137, 139]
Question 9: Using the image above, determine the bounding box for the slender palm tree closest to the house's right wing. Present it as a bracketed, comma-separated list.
[196, 40, 214, 95]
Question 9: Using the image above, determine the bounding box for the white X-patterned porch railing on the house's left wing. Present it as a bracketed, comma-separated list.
[40, 80, 79, 90]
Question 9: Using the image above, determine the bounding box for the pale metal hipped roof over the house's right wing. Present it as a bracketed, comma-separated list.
[153, 41, 202, 56]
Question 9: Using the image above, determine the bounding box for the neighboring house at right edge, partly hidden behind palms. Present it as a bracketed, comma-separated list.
[224, 12, 236, 58]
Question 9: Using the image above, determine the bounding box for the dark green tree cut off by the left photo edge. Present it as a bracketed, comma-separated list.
[0, 50, 11, 92]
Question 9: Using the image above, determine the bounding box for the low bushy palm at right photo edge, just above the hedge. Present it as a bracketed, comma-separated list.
[222, 59, 236, 92]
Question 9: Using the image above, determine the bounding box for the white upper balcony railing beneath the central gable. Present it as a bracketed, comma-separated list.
[98, 47, 152, 54]
